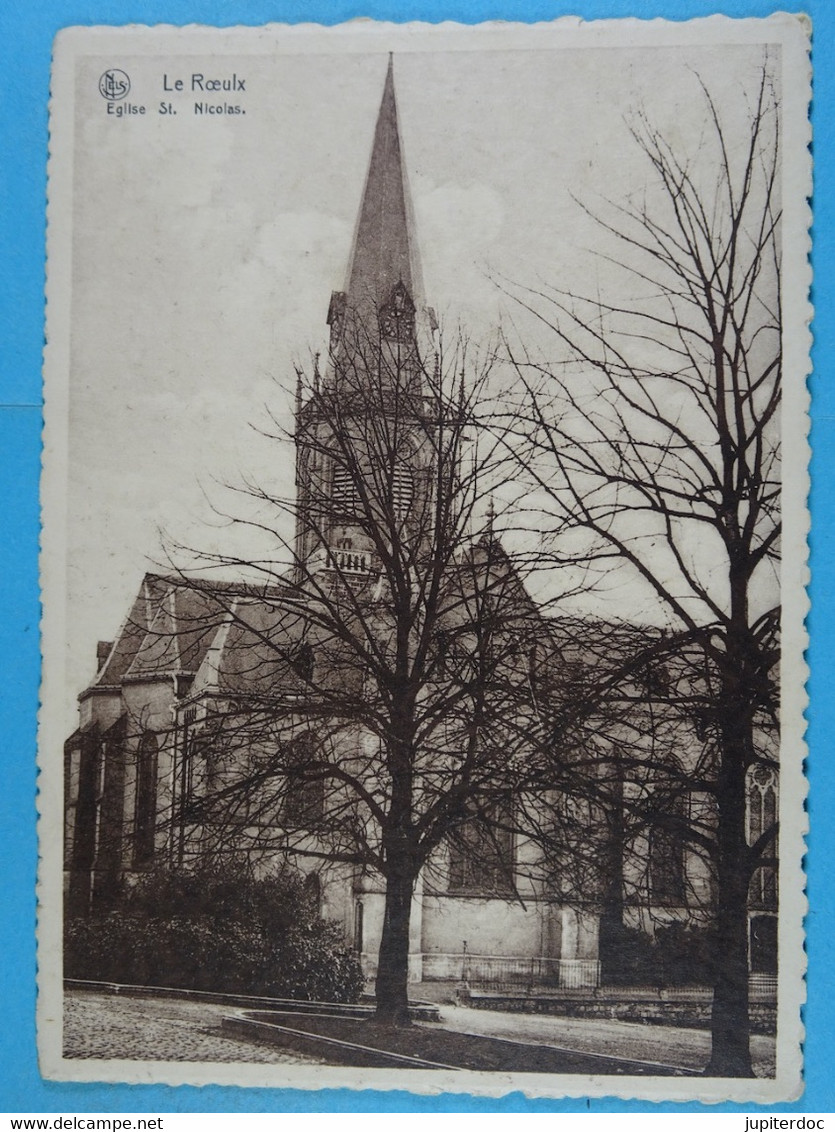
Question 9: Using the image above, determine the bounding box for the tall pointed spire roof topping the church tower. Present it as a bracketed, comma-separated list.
[345, 55, 423, 310]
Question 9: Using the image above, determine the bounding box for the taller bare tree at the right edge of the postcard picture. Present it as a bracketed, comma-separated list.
[500, 64, 781, 1077]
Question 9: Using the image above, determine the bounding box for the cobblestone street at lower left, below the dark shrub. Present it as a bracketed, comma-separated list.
[63, 991, 320, 1065]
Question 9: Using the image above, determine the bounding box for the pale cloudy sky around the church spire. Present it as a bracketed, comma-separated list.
[55, 24, 792, 726]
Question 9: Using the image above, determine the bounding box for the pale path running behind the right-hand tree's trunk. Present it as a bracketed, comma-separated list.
[434, 1005, 776, 1077]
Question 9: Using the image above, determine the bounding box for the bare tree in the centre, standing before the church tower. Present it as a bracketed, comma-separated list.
[159, 314, 549, 1023]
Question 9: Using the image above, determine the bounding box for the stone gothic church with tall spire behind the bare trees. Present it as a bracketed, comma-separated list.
[64, 61, 776, 988]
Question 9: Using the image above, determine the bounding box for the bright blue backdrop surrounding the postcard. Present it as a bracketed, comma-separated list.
[0, 0, 819, 1113]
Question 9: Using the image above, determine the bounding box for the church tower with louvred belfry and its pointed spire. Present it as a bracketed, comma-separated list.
[295, 57, 437, 584]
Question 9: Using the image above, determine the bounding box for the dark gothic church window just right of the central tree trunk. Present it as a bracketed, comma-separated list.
[449, 805, 514, 895]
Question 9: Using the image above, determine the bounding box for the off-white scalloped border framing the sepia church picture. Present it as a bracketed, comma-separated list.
[37, 14, 811, 1104]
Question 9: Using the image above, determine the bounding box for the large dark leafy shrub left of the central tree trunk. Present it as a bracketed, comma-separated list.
[64, 869, 363, 1002]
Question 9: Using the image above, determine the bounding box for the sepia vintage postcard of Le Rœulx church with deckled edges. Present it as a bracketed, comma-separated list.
[38, 15, 811, 1103]
